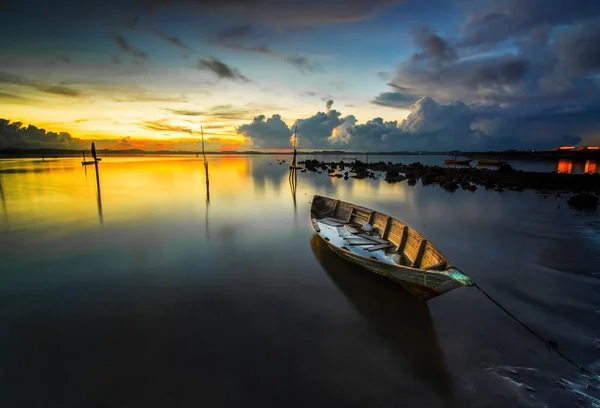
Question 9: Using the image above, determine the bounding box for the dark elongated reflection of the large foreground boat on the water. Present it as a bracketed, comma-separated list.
[310, 235, 452, 400]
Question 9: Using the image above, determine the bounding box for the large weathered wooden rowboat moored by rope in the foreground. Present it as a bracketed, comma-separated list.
[310, 195, 473, 300]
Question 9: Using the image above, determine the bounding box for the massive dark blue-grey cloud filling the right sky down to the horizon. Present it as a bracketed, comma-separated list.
[364, 0, 600, 150]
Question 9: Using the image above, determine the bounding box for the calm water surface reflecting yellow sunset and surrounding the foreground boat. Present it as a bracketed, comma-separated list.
[0, 156, 600, 407]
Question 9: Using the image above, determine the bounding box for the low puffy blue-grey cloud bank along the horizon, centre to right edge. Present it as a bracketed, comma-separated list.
[238, 97, 600, 152]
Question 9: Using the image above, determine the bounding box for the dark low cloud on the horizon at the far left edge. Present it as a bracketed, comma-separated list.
[0, 119, 86, 149]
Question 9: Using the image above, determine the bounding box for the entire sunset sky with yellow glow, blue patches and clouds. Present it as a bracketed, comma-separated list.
[0, 0, 600, 151]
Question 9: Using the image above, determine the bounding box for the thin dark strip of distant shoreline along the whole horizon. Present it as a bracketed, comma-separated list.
[0, 148, 600, 160]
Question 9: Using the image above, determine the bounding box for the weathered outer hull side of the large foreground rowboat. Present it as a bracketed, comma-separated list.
[317, 233, 463, 300]
